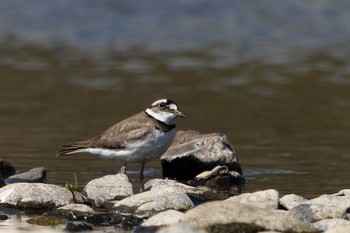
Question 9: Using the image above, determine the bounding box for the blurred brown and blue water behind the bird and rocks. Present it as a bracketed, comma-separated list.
[0, 0, 350, 198]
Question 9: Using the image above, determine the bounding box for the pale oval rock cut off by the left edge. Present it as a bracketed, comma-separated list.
[0, 183, 72, 209]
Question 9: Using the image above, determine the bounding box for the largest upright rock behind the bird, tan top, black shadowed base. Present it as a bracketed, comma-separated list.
[161, 130, 242, 180]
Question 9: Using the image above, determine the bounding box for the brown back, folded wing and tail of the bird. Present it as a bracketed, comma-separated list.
[57, 112, 153, 156]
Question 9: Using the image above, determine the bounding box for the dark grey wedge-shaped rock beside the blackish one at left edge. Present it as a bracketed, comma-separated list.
[5, 167, 46, 184]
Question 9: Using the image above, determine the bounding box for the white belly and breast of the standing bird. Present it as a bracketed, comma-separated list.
[84, 128, 176, 163]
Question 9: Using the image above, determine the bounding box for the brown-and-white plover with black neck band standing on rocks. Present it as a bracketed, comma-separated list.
[57, 99, 186, 191]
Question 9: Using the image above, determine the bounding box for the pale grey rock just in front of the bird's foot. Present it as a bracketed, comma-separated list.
[107, 187, 193, 218]
